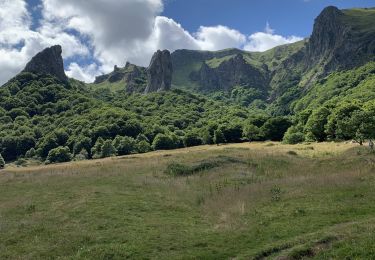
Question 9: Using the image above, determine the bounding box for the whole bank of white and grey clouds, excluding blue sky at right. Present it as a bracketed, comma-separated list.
[0, 0, 301, 84]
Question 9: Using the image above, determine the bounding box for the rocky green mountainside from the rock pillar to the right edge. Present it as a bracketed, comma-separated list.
[91, 6, 375, 115]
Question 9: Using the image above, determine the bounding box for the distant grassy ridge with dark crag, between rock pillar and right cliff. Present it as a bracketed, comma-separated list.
[172, 41, 304, 93]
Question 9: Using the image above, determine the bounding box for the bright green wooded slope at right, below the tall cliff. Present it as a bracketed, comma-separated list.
[284, 62, 375, 144]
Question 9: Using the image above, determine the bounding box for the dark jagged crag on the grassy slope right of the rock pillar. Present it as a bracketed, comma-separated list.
[190, 54, 268, 91]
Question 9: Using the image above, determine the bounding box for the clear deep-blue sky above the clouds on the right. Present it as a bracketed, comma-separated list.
[163, 0, 375, 37]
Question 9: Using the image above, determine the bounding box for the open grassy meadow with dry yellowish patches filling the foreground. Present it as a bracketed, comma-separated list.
[0, 143, 375, 259]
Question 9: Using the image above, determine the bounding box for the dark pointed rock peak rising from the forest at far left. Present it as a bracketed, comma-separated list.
[23, 45, 68, 82]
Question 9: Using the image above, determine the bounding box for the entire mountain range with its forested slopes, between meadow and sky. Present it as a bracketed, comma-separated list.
[0, 7, 375, 164]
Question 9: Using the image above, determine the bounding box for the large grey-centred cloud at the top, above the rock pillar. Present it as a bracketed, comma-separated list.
[43, 0, 163, 70]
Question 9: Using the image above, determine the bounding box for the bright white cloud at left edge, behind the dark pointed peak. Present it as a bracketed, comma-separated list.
[0, 0, 89, 84]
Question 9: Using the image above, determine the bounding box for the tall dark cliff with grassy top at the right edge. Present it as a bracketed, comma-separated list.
[270, 6, 375, 100]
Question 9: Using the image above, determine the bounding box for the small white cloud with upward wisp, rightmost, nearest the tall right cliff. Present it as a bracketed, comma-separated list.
[244, 23, 303, 51]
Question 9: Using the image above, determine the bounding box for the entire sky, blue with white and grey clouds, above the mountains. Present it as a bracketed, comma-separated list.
[0, 0, 375, 84]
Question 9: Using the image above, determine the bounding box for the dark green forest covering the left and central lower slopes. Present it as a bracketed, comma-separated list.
[0, 73, 296, 163]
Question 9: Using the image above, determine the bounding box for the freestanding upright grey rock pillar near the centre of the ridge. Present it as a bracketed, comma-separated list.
[145, 50, 173, 93]
